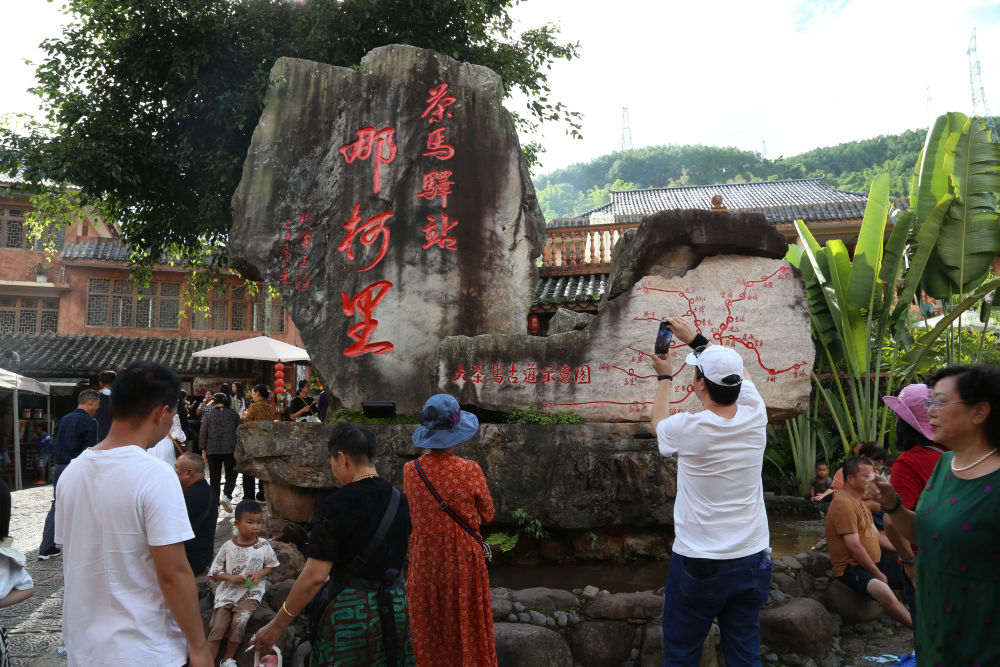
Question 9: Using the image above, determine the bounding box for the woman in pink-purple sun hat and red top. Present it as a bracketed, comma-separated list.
[882, 384, 948, 624]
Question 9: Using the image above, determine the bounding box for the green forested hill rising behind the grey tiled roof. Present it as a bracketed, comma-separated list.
[535, 130, 926, 220]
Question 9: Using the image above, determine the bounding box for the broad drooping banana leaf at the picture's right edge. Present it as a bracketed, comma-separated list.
[924, 120, 1000, 299]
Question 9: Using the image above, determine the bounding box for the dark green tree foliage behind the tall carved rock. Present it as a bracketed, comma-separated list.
[0, 0, 579, 272]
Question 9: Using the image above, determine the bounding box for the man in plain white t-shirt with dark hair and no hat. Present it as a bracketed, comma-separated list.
[56, 361, 212, 667]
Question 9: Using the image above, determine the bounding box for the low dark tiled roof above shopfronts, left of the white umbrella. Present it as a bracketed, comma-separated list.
[0, 333, 259, 378]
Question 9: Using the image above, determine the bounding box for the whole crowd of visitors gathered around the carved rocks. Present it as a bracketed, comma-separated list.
[0, 318, 1000, 667]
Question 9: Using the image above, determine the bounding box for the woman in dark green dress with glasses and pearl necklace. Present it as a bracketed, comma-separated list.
[867, 366, 1000, 667]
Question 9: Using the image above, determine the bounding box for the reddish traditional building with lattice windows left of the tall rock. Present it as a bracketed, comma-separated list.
[0, 184, 302, 394]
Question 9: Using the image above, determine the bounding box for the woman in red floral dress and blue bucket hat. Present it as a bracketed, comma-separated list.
[403, 394, 497, 667]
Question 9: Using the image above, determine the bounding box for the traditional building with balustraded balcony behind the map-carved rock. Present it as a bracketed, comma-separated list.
[531, 178, 888, 333]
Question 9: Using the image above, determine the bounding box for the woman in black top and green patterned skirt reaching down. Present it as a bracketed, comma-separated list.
[251, 424, 414, 667]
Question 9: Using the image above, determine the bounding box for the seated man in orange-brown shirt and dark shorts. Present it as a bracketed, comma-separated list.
[826, 456, 913, 628]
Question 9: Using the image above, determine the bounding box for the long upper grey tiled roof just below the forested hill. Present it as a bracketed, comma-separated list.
[550, 178, 868, 227]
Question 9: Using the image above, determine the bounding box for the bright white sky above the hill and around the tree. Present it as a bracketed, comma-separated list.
[0, 0, 1000, 174]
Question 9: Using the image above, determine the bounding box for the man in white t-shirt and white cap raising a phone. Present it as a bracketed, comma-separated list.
[651, 318, 771, 667]
